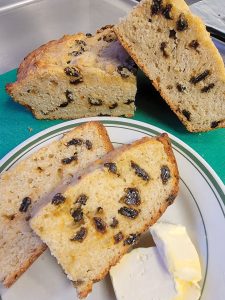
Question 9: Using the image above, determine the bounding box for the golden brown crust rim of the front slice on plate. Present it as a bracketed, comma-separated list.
[79, 133, 179, 299]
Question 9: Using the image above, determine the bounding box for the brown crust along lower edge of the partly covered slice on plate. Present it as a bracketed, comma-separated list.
[3, 244, 47, 288]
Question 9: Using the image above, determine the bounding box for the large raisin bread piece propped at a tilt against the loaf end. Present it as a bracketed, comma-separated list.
[115, 0, 225, 132]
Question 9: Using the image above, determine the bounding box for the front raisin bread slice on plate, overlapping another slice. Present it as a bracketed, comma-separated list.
[30, 134, 178, 298]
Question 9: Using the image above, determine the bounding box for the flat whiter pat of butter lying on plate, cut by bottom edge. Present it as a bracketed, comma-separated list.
[110, 247, 177, 300]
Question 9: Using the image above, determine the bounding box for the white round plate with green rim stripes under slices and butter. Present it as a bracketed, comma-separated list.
[0, 118, 225, 300]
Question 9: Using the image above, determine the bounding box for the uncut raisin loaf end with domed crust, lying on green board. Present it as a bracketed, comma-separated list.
[6, 26, 136, 119]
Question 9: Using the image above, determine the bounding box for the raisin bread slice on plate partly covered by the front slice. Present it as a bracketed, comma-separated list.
[0, 122, 112, 287]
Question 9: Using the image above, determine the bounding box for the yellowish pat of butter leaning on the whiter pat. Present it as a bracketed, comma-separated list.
[150, 223, 202, 284]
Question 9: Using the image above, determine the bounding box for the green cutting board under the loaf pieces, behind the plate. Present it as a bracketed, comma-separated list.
[0, 70, 225, 183]
